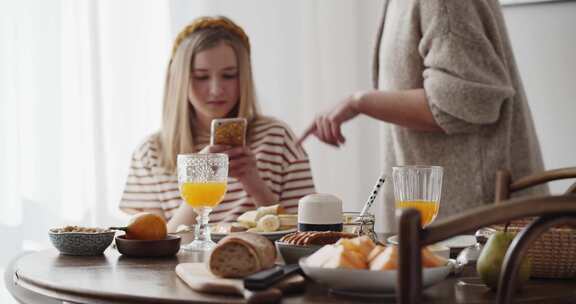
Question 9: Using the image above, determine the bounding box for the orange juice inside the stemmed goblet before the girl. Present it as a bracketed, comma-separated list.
[180, 182, 226, 208]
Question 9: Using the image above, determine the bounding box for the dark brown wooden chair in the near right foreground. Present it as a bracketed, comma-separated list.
[396, 195, 576, 303]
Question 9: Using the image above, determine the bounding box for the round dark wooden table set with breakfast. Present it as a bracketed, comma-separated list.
[6, 248, 576, 304]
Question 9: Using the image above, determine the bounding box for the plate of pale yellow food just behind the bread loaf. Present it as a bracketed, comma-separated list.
[210, 204, 298, 242]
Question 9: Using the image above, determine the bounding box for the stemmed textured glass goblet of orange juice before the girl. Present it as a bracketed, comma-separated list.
[177, 153, 228, 251]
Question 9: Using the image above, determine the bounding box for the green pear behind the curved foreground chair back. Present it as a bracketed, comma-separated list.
[476, 231, 531, 290]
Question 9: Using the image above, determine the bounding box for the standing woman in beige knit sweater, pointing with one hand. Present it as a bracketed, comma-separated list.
[300, 0, 547, 231]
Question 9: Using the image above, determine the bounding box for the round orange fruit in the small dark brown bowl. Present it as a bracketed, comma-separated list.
[126, 212, 167, 240]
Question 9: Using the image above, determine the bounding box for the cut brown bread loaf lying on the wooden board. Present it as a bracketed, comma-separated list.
[208, 232, 276, 278]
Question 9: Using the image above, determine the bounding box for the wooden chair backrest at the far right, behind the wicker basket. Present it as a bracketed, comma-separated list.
[494, 167, 576, 203]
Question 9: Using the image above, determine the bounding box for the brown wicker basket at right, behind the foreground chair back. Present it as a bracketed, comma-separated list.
[494, 219, 576, 279]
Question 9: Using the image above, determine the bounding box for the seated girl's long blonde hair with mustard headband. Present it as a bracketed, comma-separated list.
[156, 16, 260, 172]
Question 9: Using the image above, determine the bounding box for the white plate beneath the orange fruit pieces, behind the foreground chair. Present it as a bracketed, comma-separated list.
[300, 257, 452, 294]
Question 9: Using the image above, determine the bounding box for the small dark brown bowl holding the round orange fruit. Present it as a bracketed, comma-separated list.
[116, 234, 181, 257]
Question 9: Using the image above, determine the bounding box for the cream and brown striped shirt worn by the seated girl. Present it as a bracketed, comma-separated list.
[120, 119, 315, 222]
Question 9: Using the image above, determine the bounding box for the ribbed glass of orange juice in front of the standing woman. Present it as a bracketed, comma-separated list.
[392, 166, 444, 227]
